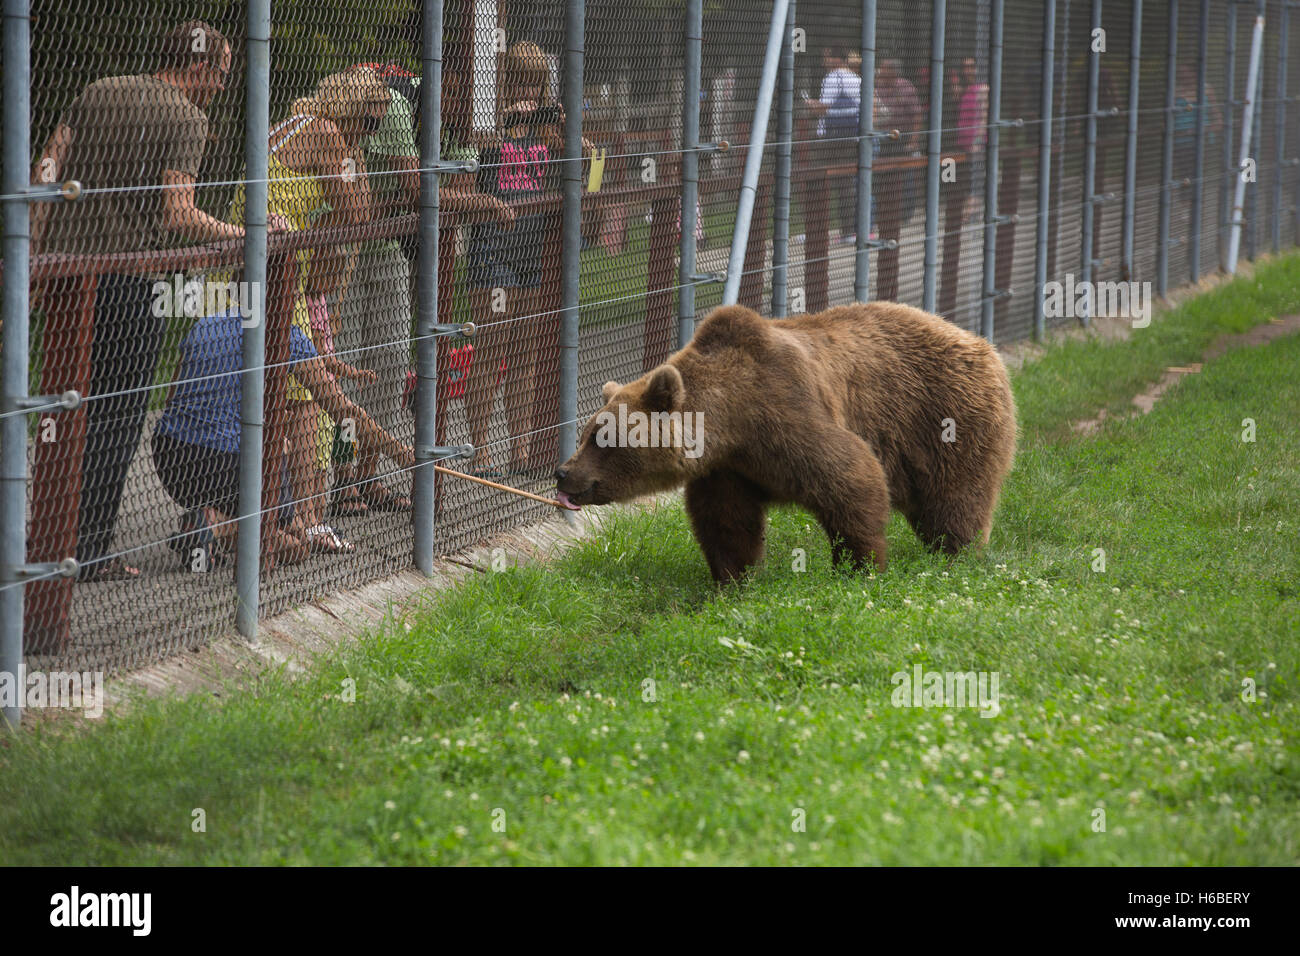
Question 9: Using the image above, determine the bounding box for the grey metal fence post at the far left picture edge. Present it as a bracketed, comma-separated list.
[0, 0, 31, 727]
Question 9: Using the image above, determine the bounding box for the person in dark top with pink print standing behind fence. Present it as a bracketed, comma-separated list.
[465, 40, 564, 477]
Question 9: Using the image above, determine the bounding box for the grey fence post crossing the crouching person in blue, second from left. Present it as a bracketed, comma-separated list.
[235, 0, 270, 641]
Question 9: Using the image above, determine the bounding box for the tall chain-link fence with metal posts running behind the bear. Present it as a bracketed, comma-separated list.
[0, 0, 1300, 712]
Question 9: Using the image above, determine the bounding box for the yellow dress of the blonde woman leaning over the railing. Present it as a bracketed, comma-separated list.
[230, 116, 334, 468]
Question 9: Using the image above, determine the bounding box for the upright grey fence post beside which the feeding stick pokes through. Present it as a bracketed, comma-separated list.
[411, 0, 442, 576]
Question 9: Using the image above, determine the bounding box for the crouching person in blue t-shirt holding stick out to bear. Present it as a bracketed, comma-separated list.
[152, 308, 415, 571]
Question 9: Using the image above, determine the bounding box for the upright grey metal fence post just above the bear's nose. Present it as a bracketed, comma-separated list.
[559, 0, 582, 462]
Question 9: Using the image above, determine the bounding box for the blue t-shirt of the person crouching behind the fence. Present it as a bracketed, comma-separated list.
[155, 310, 316, 454]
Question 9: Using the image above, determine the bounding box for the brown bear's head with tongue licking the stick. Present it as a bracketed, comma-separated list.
[555, 364, 705, 511]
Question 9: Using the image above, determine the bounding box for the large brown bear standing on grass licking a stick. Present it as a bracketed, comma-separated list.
[555, 302, 1017, 583]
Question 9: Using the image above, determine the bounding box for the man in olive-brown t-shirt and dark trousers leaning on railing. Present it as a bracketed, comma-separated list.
[31, 20, 243, 581]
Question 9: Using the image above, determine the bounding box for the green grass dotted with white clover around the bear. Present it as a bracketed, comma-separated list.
[0, 256, 1300, 865]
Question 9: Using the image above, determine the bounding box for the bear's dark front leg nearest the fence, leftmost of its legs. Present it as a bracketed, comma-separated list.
[685, 471, 767, 584]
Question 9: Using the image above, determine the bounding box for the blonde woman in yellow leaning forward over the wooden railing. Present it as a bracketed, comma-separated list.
[234, 70, 390, 553]
